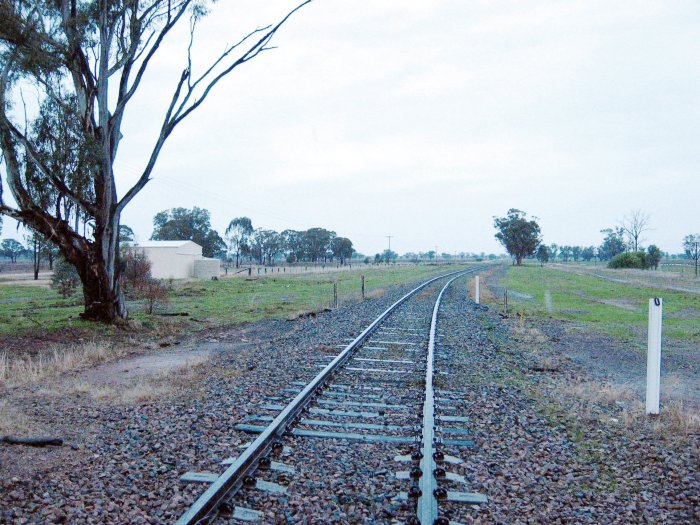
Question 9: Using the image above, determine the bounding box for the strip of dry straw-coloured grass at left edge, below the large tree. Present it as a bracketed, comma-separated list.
[0, 341, 126, 386]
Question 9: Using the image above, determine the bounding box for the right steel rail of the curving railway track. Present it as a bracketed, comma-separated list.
[416, 275, 462, 525]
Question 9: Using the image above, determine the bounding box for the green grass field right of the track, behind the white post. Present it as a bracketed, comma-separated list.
[501, 265, 700, 342]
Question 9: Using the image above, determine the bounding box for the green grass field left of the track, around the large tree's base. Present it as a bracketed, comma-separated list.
[0, 265, 470, 335]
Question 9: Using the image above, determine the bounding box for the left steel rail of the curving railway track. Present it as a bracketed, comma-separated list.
[176, 266, 483, 525]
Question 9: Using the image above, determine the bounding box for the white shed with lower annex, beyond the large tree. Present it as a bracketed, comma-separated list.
[132, 241, 221, 279]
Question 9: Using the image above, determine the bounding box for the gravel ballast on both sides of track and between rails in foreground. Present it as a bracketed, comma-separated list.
[0, 272, 700, 524]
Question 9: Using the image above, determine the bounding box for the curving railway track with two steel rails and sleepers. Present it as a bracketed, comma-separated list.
[177, 267, 486, 525]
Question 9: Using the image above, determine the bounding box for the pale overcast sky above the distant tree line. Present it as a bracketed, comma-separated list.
[3, 0, 700, 254]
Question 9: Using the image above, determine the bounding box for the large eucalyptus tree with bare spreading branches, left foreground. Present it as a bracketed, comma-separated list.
[0, 0, 311, 322]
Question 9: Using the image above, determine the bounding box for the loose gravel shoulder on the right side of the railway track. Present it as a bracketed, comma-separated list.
[440, 284, 700, 524]
